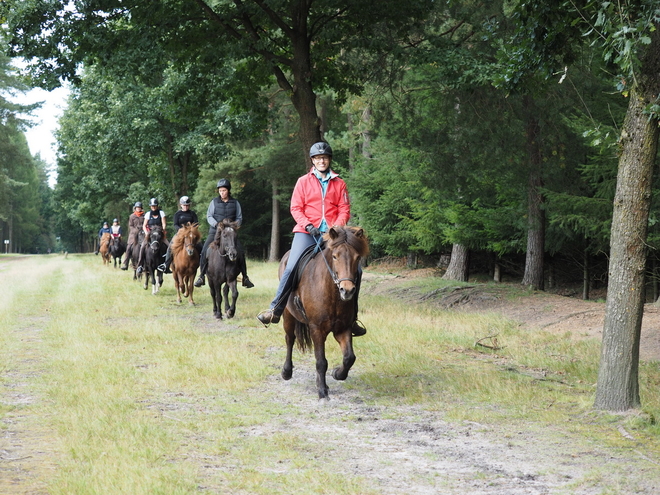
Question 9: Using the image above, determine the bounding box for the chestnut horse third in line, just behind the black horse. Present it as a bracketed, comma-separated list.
[172, 222, 202, 305]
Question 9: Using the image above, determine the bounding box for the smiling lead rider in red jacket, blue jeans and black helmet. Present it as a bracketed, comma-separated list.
[257, 142, 367, 337]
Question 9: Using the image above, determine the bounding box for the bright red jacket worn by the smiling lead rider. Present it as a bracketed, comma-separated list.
[291, 167, 351, 232]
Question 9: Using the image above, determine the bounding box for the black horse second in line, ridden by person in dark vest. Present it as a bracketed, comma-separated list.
[206, 218, 241, 319]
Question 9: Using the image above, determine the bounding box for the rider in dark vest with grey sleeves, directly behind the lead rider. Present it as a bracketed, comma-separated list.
[195, 179, 254, 289]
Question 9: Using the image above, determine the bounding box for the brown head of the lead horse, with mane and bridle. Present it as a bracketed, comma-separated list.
[325, 227, 369, 301]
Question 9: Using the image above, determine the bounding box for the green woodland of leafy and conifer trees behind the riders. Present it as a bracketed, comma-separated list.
[0, 0, 660, 300]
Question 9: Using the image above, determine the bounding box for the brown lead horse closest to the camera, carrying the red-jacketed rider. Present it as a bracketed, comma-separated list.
[279, 227, 369, 399]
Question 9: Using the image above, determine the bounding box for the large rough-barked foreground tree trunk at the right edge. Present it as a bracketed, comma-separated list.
[594, 30, 660, 411]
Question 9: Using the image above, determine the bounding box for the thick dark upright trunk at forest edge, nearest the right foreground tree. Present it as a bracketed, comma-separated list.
[522, 95, 545, 290]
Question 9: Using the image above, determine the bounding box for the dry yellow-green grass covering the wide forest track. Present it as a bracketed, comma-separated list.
[0, 255, 660, 494]
